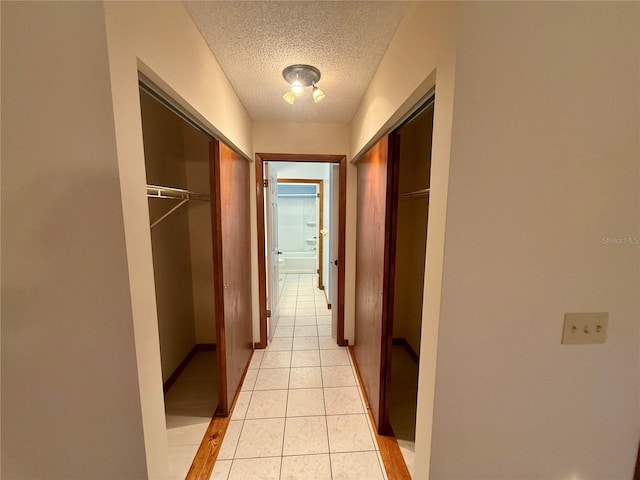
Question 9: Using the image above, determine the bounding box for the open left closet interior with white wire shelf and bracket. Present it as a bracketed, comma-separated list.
[140, 84, 224, 478]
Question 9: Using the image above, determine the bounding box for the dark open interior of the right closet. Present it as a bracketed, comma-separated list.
[383, 100, 434, 471]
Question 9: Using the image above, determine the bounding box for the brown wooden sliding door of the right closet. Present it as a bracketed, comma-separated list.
[354, 136, 393, 433]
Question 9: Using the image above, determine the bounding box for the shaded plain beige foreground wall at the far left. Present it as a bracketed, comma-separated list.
[0, 2, 148, 479]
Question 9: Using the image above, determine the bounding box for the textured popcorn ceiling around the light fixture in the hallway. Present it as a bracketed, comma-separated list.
[185, 1, 407, 123]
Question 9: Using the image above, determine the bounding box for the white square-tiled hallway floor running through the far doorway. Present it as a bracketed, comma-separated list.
[211, 274, 387, 480]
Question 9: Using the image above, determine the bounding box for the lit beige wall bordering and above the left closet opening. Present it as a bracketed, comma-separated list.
[104, 2, 252, 478]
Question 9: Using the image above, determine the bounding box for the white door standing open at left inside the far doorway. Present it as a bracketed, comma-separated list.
[264, 163, 281, 341]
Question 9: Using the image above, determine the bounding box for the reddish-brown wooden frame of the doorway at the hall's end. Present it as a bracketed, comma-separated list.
[255, 153, 348, 348]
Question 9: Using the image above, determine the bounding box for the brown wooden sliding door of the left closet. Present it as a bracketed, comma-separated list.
[210, 142, 253, 415]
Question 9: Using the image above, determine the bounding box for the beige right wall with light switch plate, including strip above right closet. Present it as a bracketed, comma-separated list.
[352, 3, 640, 479]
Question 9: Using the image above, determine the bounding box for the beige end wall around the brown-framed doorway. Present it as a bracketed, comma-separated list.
[251, 122, 357, 344]
